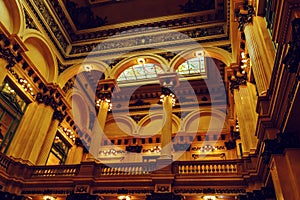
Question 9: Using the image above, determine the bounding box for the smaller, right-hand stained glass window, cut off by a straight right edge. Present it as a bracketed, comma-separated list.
[177, 56, 206, 76]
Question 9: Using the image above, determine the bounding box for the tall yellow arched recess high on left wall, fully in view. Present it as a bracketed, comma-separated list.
[23, 30, 58, 83]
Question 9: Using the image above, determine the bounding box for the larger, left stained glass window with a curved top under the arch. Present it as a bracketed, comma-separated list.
[117, 63, 163, 82]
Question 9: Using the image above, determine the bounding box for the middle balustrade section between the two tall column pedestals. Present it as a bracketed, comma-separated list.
[100, 163, 156, 176]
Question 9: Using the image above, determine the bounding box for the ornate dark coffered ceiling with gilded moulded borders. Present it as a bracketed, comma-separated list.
[25, 0, 230, 65]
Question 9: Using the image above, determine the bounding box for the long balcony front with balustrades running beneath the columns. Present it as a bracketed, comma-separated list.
[0, 154, 253, 198]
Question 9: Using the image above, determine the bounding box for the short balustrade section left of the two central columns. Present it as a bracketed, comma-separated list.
[32, 165, 79, 177]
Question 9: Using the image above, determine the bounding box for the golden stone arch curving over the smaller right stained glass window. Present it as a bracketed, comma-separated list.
[170, 47, 232, 71]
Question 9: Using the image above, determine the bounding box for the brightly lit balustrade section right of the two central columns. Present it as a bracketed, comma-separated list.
[174, 160, 238, 175]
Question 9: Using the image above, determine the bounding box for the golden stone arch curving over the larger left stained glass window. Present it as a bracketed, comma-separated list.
[110, 53, 169, 79]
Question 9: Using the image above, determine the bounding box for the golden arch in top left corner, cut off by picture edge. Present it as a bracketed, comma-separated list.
[0, 0, 25, 34]
